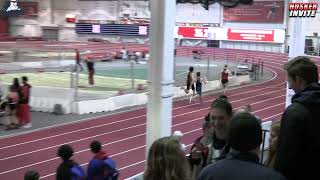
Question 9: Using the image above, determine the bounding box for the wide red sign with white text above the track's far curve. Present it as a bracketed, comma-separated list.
[228, 28, 274, 42]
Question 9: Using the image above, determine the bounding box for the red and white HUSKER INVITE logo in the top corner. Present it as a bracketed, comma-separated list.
[289, 3, 318, 18]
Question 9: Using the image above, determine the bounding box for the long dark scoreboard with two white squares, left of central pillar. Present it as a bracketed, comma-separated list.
[76, 23, 149, 36]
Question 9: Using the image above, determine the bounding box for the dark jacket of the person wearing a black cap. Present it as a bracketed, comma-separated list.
[198, 152, 285, 180]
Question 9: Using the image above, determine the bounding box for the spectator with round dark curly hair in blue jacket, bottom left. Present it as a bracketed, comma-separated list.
[56, 145, 85, 180]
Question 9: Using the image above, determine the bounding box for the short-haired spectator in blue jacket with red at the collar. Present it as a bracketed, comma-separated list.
[87, 141, 119, 180]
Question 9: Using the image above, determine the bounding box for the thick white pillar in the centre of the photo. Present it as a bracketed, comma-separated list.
[146, 0, 176, 156]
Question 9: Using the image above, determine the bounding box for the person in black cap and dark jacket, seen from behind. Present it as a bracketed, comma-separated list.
[198, 112, 286, 180]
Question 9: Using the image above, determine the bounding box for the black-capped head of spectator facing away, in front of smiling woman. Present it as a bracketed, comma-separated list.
[228, 112, 262, 152]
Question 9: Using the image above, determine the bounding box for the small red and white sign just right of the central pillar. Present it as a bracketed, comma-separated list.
[178, 27, 209, 39]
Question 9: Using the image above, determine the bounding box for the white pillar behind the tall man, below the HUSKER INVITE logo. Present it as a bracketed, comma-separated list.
[286, 0, 308, 107]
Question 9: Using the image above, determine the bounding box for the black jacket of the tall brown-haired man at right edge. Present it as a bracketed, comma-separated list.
[275, 83, 320, 180]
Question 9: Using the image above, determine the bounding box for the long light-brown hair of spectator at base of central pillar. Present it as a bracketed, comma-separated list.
[144, 137, 190, 180]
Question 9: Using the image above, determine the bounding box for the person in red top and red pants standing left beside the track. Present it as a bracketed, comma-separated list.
[18, 76, 31, 128]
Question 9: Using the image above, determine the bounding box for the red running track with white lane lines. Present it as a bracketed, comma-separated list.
[0, 47, 320, 180]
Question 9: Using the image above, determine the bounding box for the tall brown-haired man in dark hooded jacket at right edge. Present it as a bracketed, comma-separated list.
[275, 56, 320, 180]
